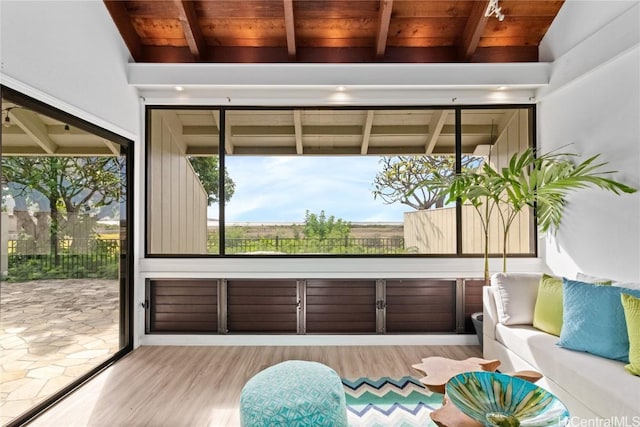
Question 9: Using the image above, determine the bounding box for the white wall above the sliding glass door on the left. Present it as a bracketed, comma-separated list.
[0, 0, 140, 139]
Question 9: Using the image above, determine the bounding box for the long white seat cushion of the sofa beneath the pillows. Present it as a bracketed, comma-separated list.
[496, 325, 640, 419]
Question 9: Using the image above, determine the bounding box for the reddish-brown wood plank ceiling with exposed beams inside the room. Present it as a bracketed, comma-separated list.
[104, 0, 563, 63]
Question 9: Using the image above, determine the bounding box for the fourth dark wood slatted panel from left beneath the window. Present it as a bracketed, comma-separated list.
[386, 279, 456, 333]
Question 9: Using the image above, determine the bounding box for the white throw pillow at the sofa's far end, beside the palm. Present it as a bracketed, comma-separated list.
[491, 273, 542, 325]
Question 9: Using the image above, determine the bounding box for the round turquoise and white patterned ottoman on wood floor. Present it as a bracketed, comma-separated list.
[240, 360, 347, 427]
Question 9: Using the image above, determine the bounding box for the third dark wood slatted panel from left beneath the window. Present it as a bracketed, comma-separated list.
[306, 280, 376, 333]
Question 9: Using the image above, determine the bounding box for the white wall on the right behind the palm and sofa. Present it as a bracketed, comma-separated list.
[538, 1, 640, 281]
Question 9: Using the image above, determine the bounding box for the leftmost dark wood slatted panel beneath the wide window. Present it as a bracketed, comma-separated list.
[148, 280, 218, 333]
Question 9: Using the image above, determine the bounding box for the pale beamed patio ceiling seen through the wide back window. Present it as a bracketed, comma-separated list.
[150, 108, 512, 156]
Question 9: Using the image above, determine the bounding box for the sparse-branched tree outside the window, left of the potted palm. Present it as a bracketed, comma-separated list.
[373, 155, 480, 210]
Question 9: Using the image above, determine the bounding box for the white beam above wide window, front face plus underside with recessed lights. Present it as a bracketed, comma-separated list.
[127, 63, 551, 106]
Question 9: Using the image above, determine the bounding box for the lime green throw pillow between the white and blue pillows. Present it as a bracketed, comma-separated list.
[533, 274, 562, 337]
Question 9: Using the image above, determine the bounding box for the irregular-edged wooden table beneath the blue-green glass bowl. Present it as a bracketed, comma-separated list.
[412, 356, 542, 427]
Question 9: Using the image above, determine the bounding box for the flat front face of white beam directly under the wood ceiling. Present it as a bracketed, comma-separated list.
[127, 62, 550, 91]
